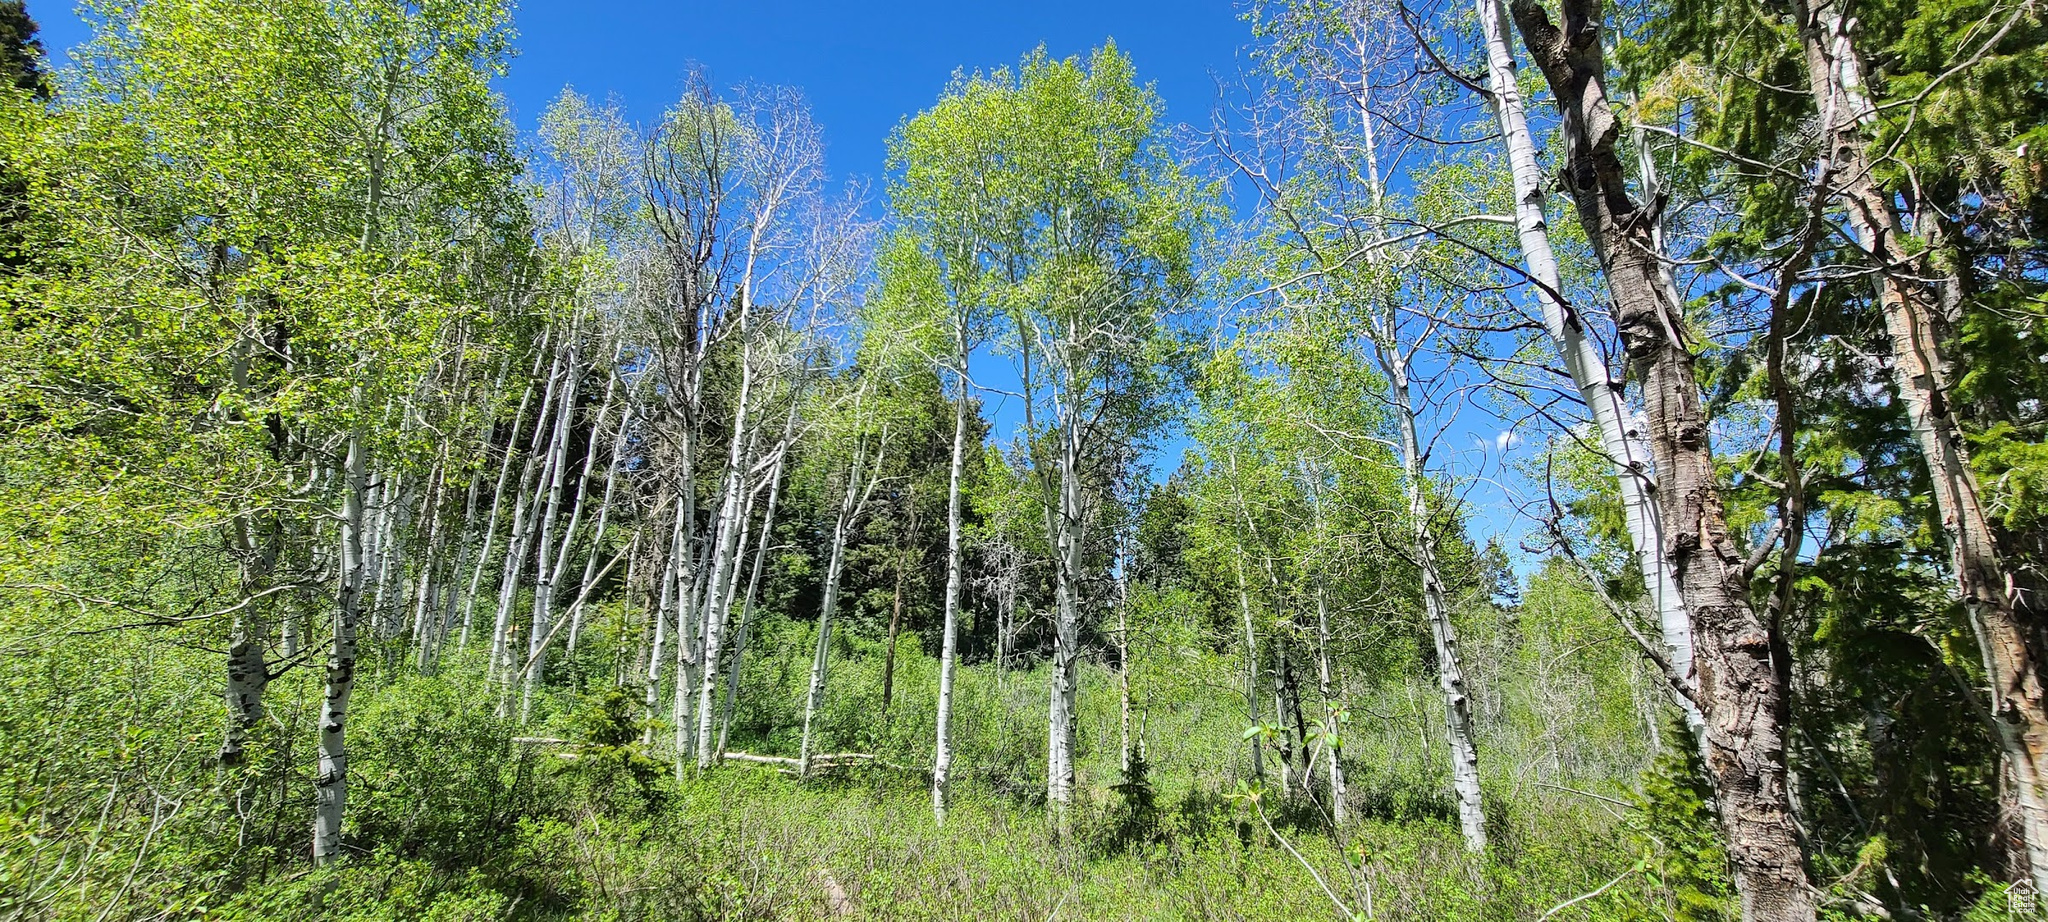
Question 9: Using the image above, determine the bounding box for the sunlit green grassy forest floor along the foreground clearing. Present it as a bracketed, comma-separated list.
[228, 766, 1665, 922]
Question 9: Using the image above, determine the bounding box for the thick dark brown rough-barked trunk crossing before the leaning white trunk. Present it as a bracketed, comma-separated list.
[1513, 0, 1815, 905]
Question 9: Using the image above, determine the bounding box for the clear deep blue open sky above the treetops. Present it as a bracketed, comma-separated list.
[29, 0, 1249, 188]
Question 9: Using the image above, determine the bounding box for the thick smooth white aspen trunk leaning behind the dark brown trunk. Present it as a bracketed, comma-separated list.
[1477, 0, 1706, 725]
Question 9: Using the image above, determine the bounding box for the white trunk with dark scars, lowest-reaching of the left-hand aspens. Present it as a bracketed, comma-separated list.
[313, 434, 369, 867]
